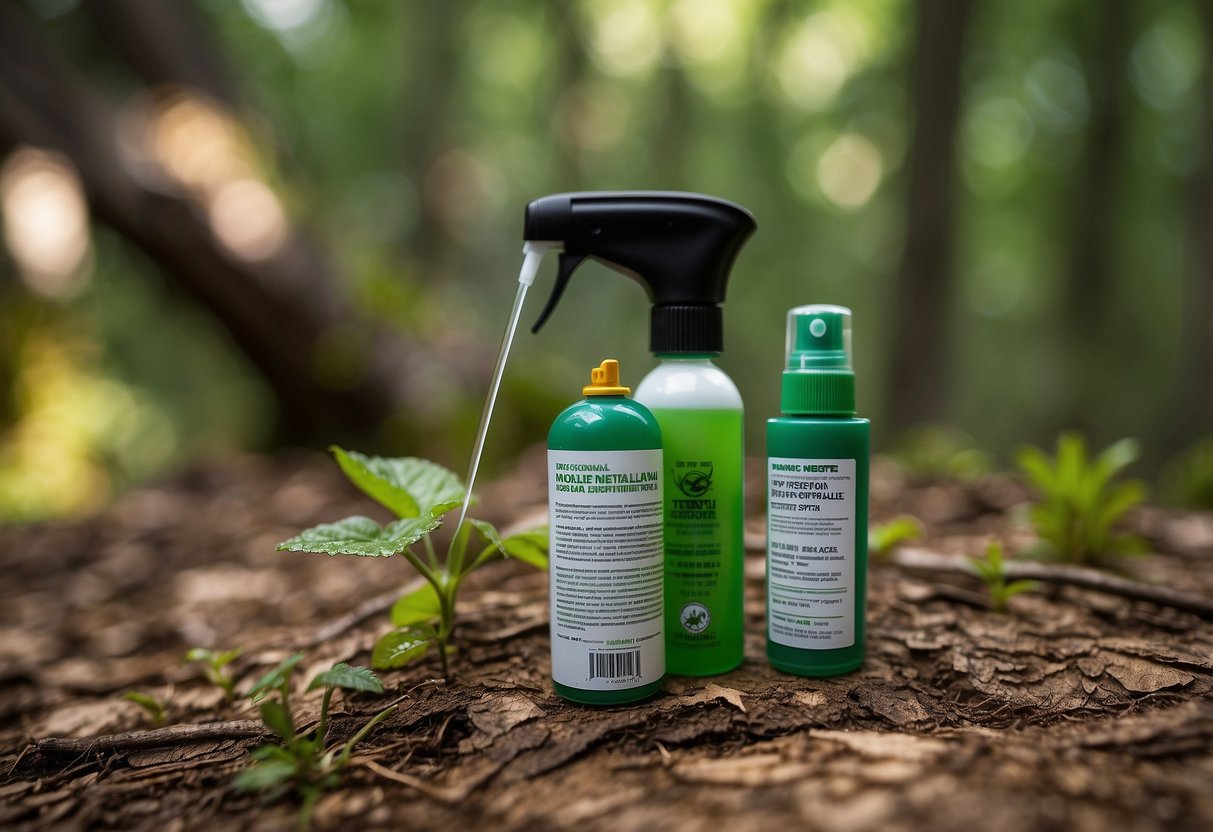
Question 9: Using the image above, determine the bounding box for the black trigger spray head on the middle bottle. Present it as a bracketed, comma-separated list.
[523, 190, 756, 353]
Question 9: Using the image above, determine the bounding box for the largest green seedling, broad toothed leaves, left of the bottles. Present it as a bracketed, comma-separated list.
[278, 446, 548, 678]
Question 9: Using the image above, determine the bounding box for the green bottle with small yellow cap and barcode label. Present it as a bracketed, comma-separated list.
[547, 359, 666, 705]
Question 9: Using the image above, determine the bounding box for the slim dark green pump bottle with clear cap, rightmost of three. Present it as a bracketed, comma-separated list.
[767, 304, 869, 676]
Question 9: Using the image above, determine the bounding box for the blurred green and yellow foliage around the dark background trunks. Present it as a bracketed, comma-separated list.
[0, 0, 1213, 518]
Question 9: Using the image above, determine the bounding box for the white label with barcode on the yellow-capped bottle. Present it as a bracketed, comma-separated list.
[547, 450, 666, 690]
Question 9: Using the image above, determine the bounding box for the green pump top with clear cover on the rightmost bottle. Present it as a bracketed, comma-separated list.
[780, 303, 855, 416]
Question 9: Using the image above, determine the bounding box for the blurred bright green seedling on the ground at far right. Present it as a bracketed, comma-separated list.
[1018, 433, 1146, 564]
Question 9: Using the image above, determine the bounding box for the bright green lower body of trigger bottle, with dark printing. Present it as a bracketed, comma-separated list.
[654, 410, 745, 673]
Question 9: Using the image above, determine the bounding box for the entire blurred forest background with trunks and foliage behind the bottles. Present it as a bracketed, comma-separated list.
[0, 0, 1213, 520]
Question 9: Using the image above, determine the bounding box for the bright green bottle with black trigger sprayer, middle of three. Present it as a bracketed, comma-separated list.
[524, 192, 756, 676]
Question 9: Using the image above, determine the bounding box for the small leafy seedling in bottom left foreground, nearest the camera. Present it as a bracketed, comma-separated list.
[232, 653, 395, 830]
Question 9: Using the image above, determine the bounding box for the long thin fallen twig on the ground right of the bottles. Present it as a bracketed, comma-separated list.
[887, 548, 1213, 619]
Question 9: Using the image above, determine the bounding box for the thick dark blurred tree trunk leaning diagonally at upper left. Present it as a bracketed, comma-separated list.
[0, 2, 405, 443]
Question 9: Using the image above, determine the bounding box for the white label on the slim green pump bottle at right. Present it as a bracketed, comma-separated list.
[767, 456, 855, 650]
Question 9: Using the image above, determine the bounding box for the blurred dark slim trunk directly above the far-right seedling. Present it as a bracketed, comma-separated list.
[1063, 2, 1138, 439]
